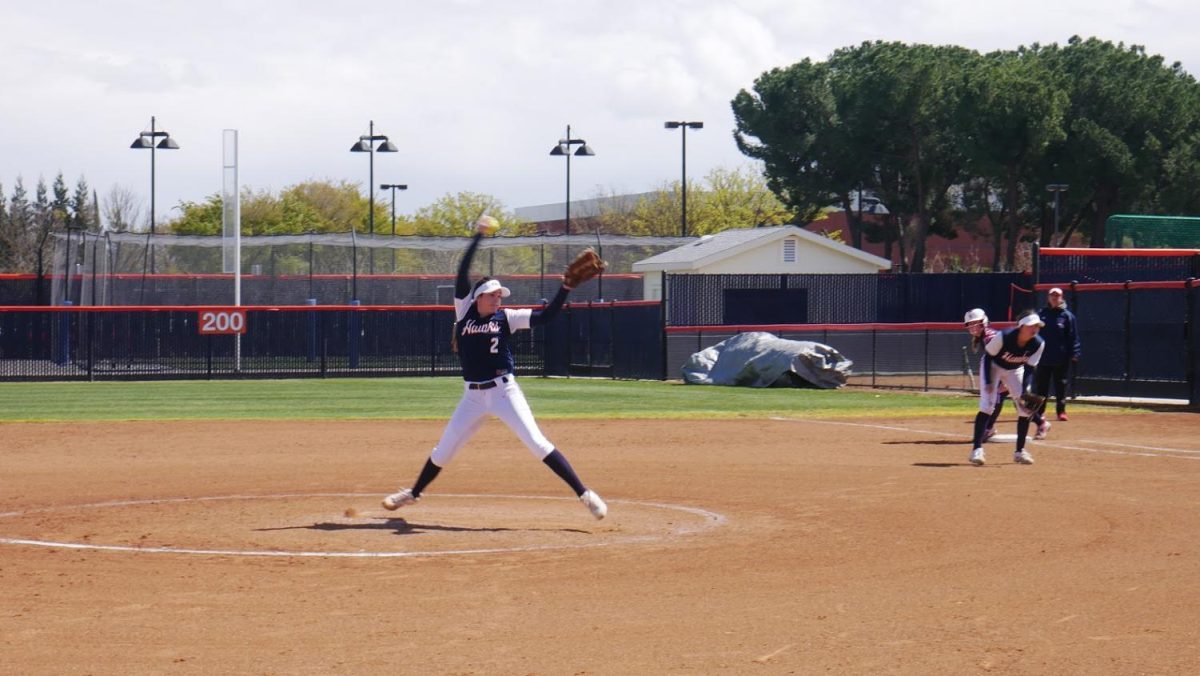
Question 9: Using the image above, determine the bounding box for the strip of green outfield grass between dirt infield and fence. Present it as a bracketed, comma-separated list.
[0, 377, 1111, 421]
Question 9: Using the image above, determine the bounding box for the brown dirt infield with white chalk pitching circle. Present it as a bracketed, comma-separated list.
[0, 409, 1200, 675]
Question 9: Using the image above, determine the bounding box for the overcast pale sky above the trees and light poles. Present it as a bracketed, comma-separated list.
[0, 0, 1200, 222]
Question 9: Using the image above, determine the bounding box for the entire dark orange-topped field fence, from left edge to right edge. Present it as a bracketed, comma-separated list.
[0, 280, 1200, 405]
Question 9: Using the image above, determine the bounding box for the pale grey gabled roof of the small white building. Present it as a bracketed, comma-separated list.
[632, 226, 892, 273]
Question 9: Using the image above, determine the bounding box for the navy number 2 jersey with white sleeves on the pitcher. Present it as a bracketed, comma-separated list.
[454, 298, 533, 382]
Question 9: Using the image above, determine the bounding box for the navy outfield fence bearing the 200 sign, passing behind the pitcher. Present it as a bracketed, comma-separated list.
[0, 301, 662, 381]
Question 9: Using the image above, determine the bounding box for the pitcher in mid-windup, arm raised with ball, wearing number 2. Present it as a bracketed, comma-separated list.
[383, 220, 608, 519]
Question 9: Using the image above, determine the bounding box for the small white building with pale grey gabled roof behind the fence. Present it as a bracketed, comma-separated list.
[632, 226, 892, 300]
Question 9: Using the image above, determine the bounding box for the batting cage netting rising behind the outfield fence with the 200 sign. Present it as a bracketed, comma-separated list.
[46, 232, 692, 306]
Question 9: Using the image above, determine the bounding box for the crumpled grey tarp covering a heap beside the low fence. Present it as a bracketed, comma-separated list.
[683, 331, 854, 389]
